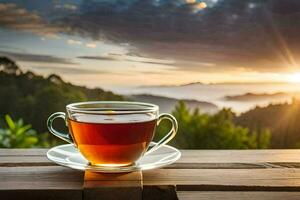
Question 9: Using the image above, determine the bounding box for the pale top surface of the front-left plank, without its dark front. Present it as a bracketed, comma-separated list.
[0, 166, 83, 190]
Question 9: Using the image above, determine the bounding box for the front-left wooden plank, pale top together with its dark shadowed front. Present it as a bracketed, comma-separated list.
[0, 166, 83, 200]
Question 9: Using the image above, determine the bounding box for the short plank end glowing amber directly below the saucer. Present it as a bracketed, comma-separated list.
[83, 171, 143, 200]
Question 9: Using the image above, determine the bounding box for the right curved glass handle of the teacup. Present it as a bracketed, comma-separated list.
[145, 113, 178, 155]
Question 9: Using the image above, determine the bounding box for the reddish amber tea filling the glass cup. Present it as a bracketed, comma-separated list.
[69, 115, 156, 166]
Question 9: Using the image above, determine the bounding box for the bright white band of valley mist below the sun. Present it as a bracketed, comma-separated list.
[114, 82, 300, 113]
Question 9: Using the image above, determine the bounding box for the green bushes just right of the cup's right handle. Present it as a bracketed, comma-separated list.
[156, 102, 270, 149]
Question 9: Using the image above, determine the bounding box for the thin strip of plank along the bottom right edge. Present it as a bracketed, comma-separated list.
[177, 191, 300, 200]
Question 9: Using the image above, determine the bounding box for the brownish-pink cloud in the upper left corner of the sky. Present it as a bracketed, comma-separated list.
[0, 3, 62, 36]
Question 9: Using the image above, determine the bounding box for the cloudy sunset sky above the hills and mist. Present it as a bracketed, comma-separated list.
[0, 0, 300, 87]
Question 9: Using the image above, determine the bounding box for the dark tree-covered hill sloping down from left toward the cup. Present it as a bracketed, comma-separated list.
[0, 57, 124, 132]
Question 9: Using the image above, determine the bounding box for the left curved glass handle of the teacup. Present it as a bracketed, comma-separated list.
[47, 112, 73, 144]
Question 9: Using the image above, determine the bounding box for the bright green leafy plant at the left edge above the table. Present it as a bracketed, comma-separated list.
[0, 115, 38, 148]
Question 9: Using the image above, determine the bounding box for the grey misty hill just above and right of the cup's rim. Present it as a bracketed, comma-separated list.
[127, 94, 218, 113]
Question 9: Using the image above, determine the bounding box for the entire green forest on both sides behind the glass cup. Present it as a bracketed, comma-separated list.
[0, 57, 300, 149]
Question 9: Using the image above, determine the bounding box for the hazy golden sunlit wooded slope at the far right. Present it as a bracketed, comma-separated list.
[234, 99, 300, 148]
